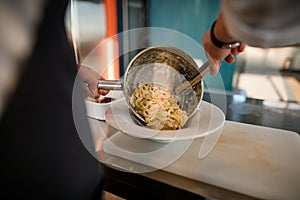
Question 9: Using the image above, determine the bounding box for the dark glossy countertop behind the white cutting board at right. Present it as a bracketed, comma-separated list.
[203, 92, 300, 134]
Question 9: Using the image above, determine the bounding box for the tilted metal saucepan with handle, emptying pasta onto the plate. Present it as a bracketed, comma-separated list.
[98, 46, 208, 122]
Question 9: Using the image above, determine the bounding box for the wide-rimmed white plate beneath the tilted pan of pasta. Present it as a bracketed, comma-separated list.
[105, 99, 225, 143]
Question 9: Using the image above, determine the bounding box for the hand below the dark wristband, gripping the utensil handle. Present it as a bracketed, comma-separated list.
[202, 27, 245, 75]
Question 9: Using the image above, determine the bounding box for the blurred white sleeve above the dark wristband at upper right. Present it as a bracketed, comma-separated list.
[221, 0, 300, 47]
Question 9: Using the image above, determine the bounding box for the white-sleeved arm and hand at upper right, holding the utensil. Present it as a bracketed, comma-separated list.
[202, 0, 300, 75]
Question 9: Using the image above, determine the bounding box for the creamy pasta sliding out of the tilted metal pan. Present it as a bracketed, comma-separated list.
[130, 84, 188, 130]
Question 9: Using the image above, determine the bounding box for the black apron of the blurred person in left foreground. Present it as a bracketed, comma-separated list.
[0, 0, 102, 200]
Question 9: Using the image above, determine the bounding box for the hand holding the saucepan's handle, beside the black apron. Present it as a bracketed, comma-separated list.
[78, 65, 109, 99]
